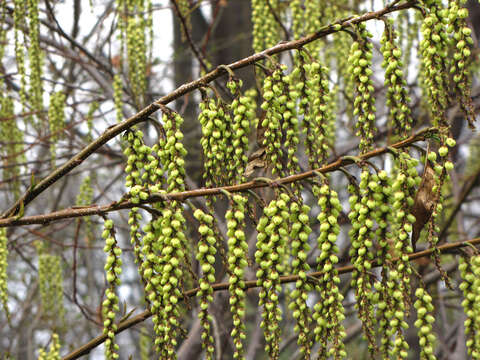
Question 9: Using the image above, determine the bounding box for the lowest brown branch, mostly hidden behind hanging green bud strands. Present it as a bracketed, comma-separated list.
[63, 238, 480, 360]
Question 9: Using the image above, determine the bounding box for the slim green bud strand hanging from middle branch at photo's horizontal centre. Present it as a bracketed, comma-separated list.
[225, 195, 248, 359]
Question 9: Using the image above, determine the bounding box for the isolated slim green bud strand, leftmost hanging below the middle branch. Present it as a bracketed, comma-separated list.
[102, 219, 122, 360]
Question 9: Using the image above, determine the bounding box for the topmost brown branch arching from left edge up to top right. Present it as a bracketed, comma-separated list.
[2, 0, 417, 218]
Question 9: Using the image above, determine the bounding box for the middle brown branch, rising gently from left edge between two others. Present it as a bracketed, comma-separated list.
[0, 128, 437, 227]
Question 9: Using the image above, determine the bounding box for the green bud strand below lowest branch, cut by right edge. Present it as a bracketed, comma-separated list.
[458, 254, 480, 360]
